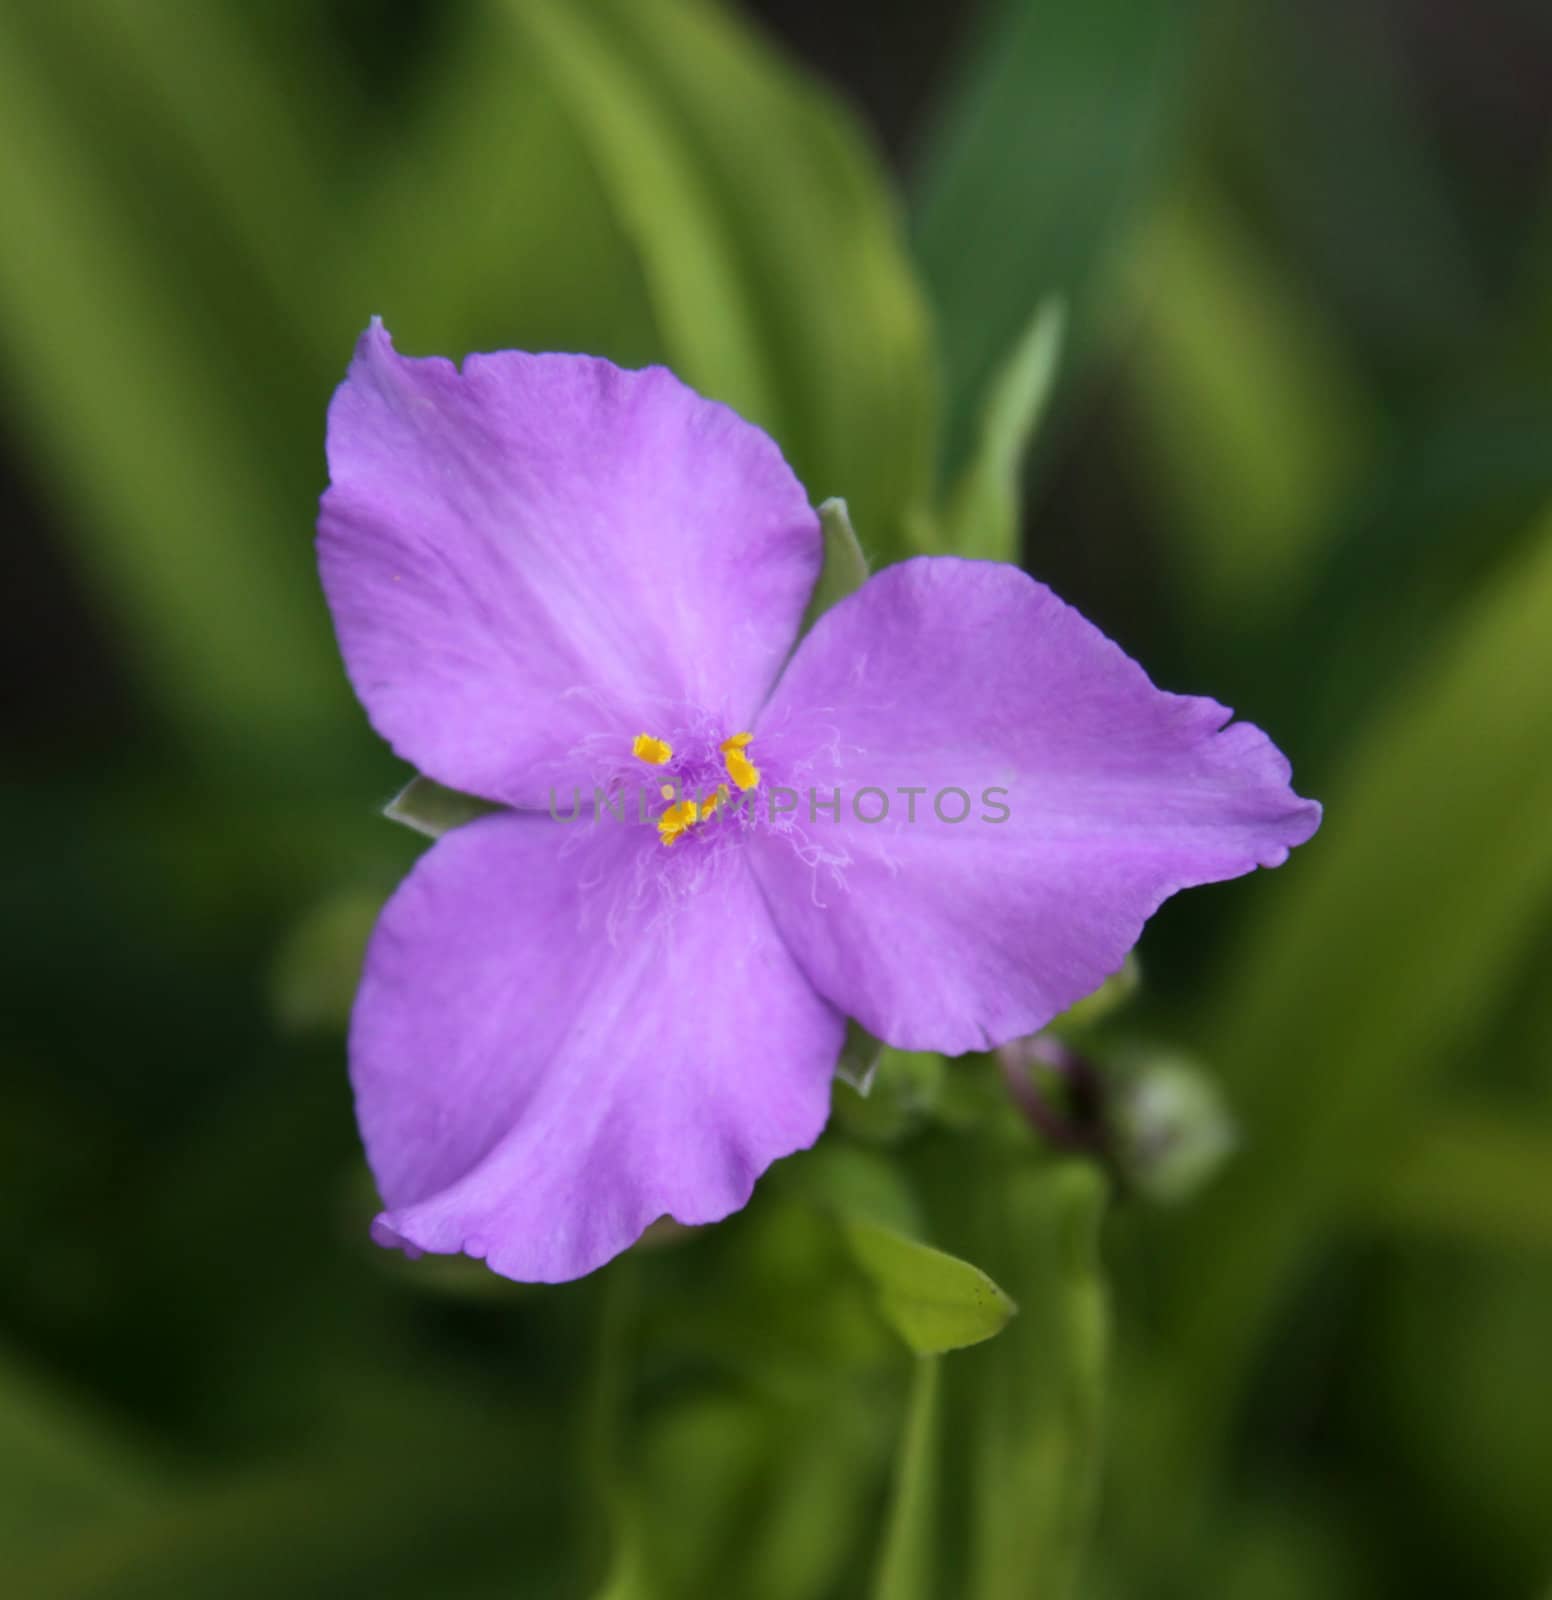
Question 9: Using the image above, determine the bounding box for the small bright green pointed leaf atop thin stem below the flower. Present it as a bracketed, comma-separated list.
[842, 1218, 1018, 1355]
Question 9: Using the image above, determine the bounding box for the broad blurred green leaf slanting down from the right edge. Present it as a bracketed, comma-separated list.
[1122, 508, 1552, 1563]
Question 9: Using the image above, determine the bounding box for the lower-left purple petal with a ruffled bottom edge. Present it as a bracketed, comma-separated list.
[350, 813, 843, 1283]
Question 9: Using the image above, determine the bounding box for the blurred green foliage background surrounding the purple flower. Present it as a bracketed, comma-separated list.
[0, 0, 1552, 1600]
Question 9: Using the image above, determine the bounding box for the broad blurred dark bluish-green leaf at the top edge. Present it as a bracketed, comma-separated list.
[914, 0, 1202, 470]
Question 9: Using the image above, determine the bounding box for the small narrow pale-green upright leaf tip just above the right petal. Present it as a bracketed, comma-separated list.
[944, 299, 1067, 562]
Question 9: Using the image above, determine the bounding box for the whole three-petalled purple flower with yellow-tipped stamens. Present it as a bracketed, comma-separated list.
[318, 323, 1320, 1282]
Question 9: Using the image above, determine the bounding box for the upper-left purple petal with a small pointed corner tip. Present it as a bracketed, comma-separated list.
[318, 322, 821, 806]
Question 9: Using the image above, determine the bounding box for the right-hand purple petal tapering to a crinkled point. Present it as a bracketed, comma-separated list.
[754, 558, 1320, 1053]
